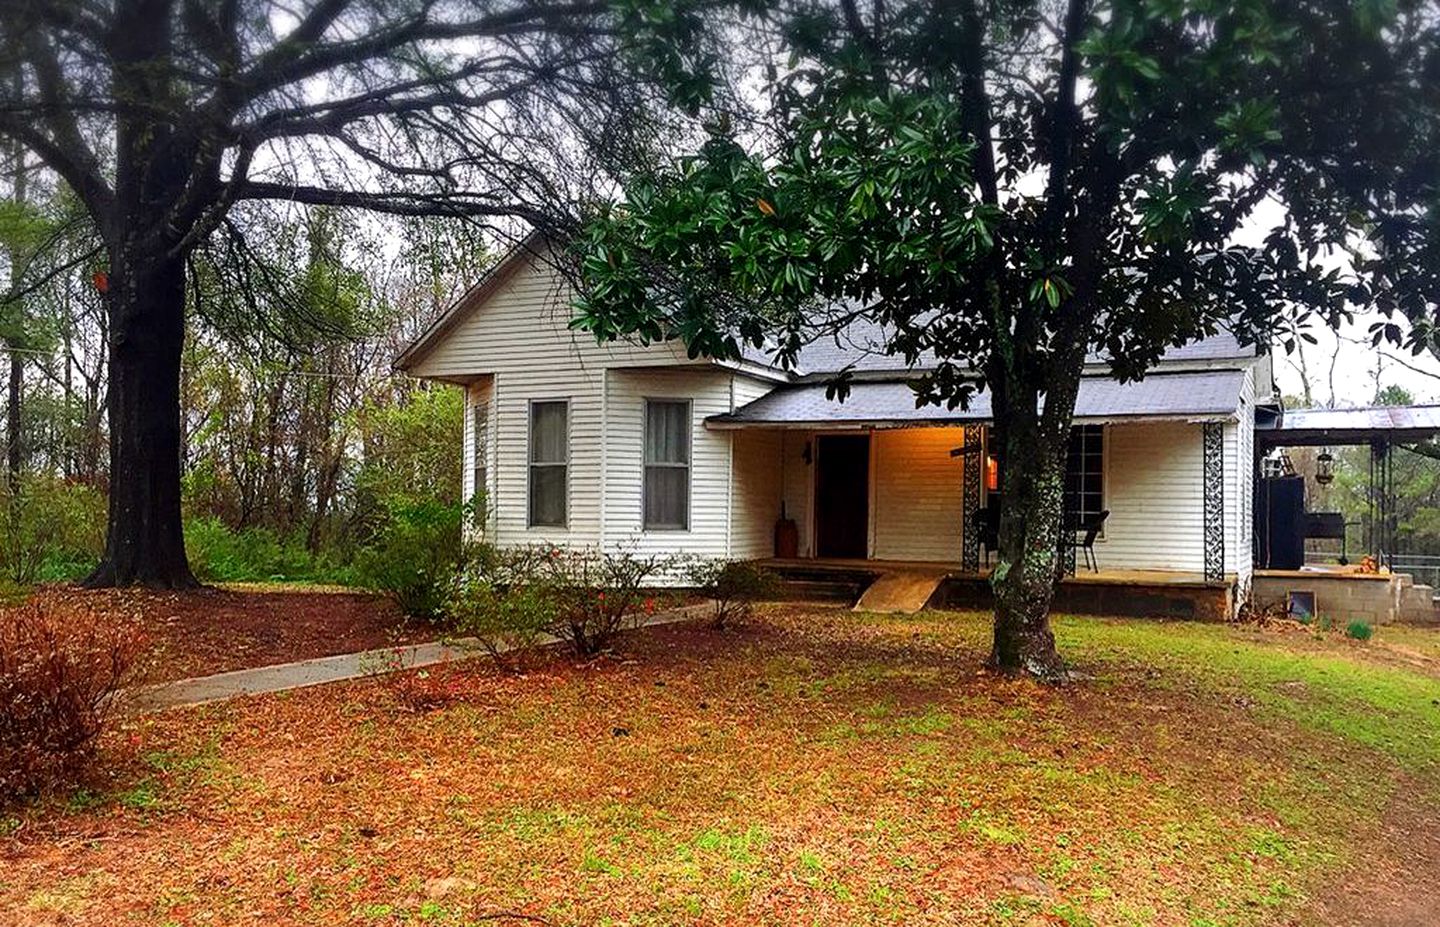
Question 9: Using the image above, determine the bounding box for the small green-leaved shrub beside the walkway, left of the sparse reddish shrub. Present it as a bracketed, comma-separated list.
[445, 547, 560, 671]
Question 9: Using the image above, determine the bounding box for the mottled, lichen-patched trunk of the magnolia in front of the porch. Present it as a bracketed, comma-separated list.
[991, 423, 1066, 679]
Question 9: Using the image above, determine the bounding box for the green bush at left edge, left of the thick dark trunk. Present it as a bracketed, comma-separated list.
[0, 475, 105, 584]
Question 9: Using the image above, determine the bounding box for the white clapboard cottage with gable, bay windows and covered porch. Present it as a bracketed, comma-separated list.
[396, 238, 1274, 607]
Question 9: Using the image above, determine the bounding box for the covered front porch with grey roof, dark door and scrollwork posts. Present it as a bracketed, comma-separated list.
[720, 371, 1253, 583]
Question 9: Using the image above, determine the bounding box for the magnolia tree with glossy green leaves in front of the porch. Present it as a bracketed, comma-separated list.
[576, 0, 1440, 678]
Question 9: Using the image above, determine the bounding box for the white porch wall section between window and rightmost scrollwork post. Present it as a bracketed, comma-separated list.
[1096, 422, 1205, 573]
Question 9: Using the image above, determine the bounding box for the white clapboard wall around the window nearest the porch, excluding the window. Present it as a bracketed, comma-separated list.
[603, 367, 733, 557]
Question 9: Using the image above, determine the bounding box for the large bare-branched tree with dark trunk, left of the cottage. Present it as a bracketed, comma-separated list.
[0, 0, 720, 586]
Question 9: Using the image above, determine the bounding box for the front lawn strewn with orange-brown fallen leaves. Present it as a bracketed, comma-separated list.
[0, 606, 1440, 927]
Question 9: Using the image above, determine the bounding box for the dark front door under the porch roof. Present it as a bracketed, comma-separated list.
[815, 435, 870, 560]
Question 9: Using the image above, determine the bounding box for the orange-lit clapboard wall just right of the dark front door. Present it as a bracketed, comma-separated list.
[870, 428, 965, 560]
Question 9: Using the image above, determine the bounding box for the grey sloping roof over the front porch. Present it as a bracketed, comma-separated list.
[706, 370, 1246, 429]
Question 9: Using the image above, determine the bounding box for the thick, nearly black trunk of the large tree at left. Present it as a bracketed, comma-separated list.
[86, 253, 197, 589]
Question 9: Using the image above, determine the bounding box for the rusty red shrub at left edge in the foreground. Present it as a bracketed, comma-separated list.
[0, 600, 144, 803]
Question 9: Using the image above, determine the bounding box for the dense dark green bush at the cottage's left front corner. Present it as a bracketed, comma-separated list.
[356, 498, 469, 619]
